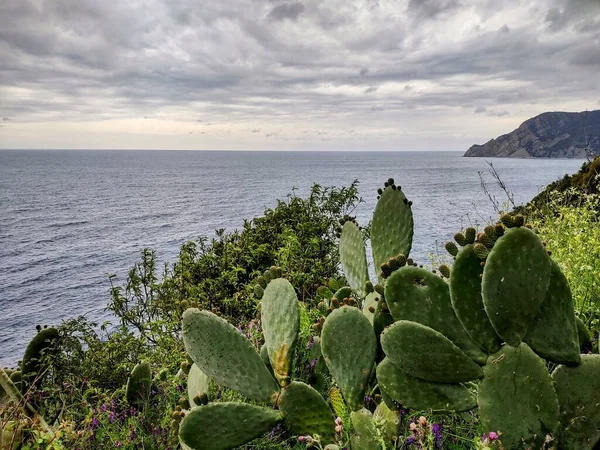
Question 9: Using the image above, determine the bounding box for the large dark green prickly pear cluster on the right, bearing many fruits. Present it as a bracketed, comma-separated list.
[332, 180, 600, 450]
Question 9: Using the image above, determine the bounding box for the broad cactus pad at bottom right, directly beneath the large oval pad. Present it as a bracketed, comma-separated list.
[477, 343, 558, 450]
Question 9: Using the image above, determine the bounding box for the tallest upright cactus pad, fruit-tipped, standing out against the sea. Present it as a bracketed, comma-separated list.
[371, 182, 413, 280]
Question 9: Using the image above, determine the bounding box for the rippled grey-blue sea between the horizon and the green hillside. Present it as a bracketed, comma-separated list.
[0, 151, 582, 365]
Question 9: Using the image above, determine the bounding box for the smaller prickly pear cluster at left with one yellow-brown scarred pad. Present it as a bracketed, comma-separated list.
[174, 274, 342, 450]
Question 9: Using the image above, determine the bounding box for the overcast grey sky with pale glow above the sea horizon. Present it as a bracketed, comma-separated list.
[0, 0, 600, 151]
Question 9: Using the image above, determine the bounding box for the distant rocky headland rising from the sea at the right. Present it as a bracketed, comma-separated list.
[464, 110, 600, 158]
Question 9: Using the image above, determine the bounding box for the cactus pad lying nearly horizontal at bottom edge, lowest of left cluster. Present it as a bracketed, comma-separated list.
[179, 402, 281, 450]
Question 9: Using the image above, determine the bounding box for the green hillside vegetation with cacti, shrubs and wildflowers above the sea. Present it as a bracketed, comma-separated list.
[0, 165, 600, 450]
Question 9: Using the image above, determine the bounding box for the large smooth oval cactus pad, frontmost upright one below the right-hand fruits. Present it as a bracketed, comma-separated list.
[481, 228, 551, 347]
